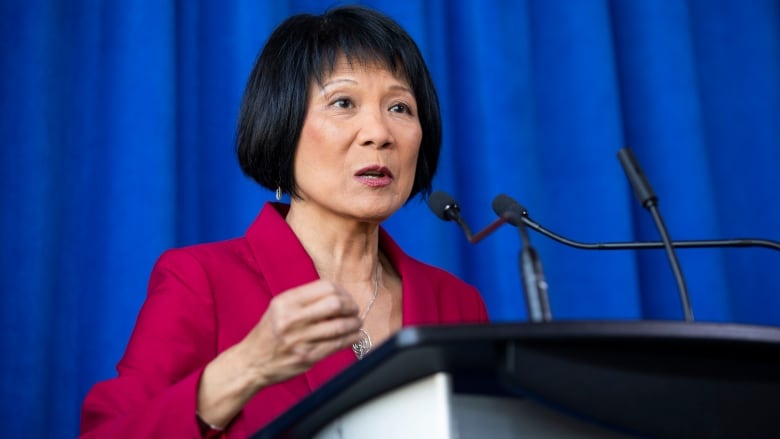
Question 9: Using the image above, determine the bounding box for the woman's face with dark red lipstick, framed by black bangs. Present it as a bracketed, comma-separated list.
[292, 57, 422, 222]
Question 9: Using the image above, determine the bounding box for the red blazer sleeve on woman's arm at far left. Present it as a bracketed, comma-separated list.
[81, 249, 224, 438]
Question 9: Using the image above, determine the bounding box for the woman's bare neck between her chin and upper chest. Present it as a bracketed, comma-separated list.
[286, 201, 379, 284]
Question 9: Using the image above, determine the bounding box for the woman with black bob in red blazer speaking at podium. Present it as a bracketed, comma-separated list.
[77, 7, 487, 438]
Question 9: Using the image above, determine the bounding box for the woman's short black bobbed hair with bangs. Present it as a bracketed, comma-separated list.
[236, 6, 442, 199]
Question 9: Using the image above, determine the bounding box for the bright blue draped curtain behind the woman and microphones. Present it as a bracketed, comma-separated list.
[0, 0, 780, 437]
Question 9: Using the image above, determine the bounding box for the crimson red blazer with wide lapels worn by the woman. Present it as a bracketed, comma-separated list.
[81, 203, 488, 438]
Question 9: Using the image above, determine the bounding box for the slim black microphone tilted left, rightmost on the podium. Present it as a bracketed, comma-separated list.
[618, 148, 693, 322]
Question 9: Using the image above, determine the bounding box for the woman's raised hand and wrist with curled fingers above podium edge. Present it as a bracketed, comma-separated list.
[198, 280, 361, 426]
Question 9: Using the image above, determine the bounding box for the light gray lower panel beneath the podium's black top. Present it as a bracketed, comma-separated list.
[315, 372, 629, 439]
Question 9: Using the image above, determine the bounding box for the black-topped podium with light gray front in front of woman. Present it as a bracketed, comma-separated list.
[252, 321, 780, 439]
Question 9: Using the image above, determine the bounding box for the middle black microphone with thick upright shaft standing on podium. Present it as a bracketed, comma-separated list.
[493, 194, 552, 322]
